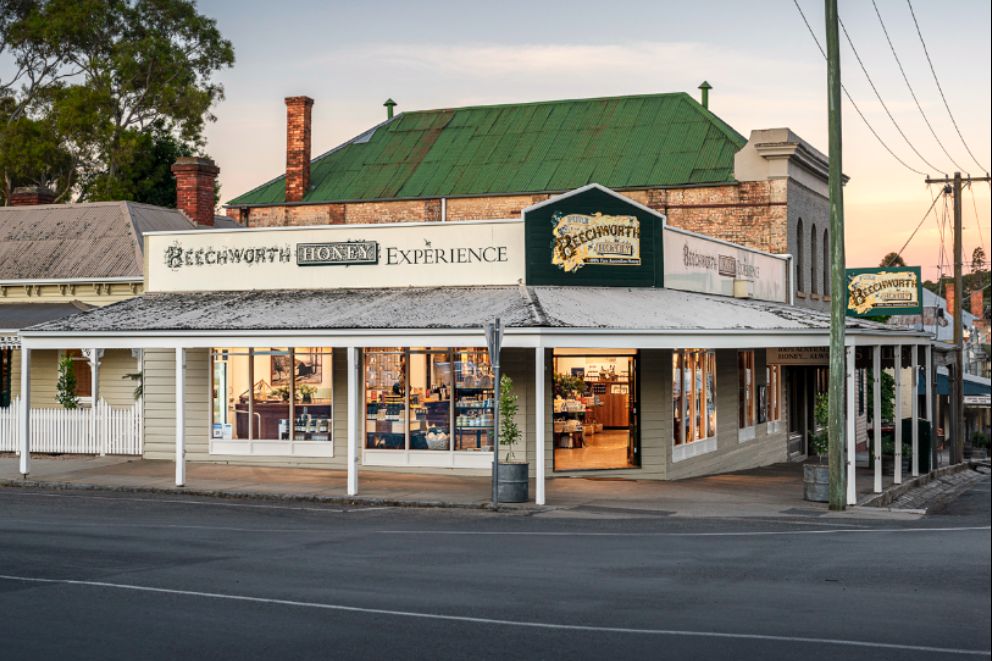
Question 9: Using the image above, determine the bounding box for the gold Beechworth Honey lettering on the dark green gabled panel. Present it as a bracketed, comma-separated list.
[551, 212, 641, 273]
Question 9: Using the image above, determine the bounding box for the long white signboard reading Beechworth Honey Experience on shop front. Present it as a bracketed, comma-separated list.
[145, 220, 525, 291]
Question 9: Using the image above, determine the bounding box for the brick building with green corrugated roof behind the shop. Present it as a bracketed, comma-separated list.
[227, 91, 830, 310]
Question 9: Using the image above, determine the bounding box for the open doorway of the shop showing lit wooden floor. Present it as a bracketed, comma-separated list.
[553, 349, 640, 471]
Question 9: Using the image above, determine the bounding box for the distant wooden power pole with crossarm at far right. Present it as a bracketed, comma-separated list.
[926, 172, 989, 464]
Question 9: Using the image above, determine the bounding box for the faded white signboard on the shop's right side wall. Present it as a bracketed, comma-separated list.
[662, 227, 789, 303]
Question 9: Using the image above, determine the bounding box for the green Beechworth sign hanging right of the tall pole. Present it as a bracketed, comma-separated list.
[847, 266, 922, 317]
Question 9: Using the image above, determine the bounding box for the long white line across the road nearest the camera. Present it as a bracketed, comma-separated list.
[0, 574, 992, 656]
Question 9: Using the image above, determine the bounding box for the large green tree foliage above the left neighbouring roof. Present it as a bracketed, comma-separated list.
[0, 0, 234, 206]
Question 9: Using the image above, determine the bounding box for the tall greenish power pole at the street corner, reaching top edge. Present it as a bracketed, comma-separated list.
[825, 0, 854, 510]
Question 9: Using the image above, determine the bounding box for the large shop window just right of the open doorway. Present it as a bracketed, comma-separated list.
[672, 349, 716, 445]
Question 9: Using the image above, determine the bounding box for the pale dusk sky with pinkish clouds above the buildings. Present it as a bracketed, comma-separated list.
[197, 0, 992, 279]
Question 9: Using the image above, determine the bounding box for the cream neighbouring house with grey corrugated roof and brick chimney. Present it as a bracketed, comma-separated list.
[0, 158, 237, 450]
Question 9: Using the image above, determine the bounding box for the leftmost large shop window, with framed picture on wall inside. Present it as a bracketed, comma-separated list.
[211, 347, 333, 441]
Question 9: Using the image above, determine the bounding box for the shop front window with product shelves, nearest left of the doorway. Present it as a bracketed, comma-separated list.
[365, 347, 495, 451]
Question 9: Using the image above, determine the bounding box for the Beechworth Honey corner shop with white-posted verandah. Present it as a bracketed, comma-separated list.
[15, 184, 932, 502]
